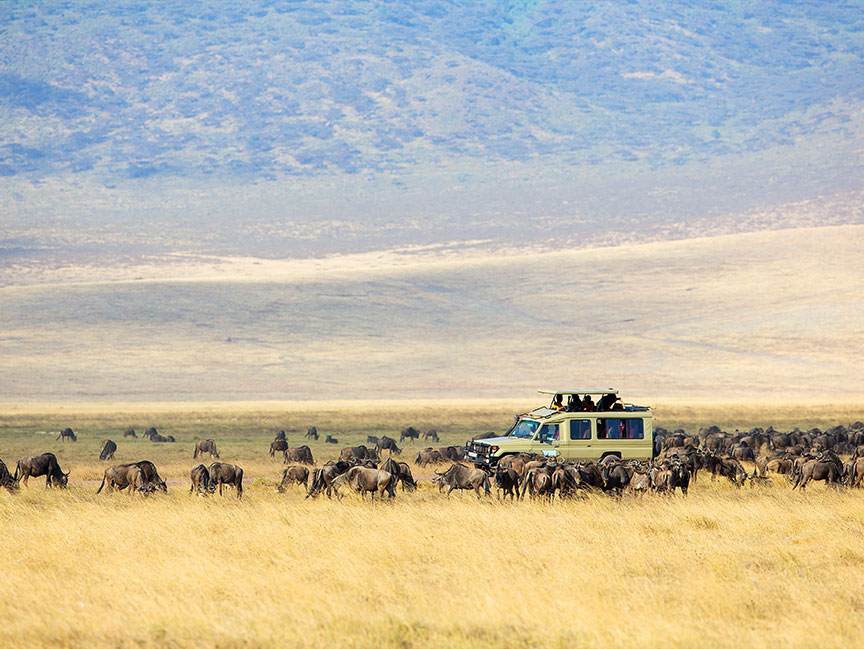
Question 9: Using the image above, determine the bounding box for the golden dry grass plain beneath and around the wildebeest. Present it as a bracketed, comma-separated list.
[0, 401, 864, 648]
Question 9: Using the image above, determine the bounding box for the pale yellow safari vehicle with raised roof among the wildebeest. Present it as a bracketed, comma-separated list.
[466, 388, 654, 466]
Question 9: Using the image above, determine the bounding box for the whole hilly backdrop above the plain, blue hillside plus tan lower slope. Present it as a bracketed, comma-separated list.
[0, 2, 864, 400]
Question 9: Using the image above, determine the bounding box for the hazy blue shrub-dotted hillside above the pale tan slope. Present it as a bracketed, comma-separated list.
[0, 0, 864, 255]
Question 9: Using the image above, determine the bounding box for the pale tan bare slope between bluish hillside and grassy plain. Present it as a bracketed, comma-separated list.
[0, 226, 864, 403]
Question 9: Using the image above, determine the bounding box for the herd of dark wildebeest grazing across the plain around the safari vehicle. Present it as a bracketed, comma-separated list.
[0, 422, 864, 500]
